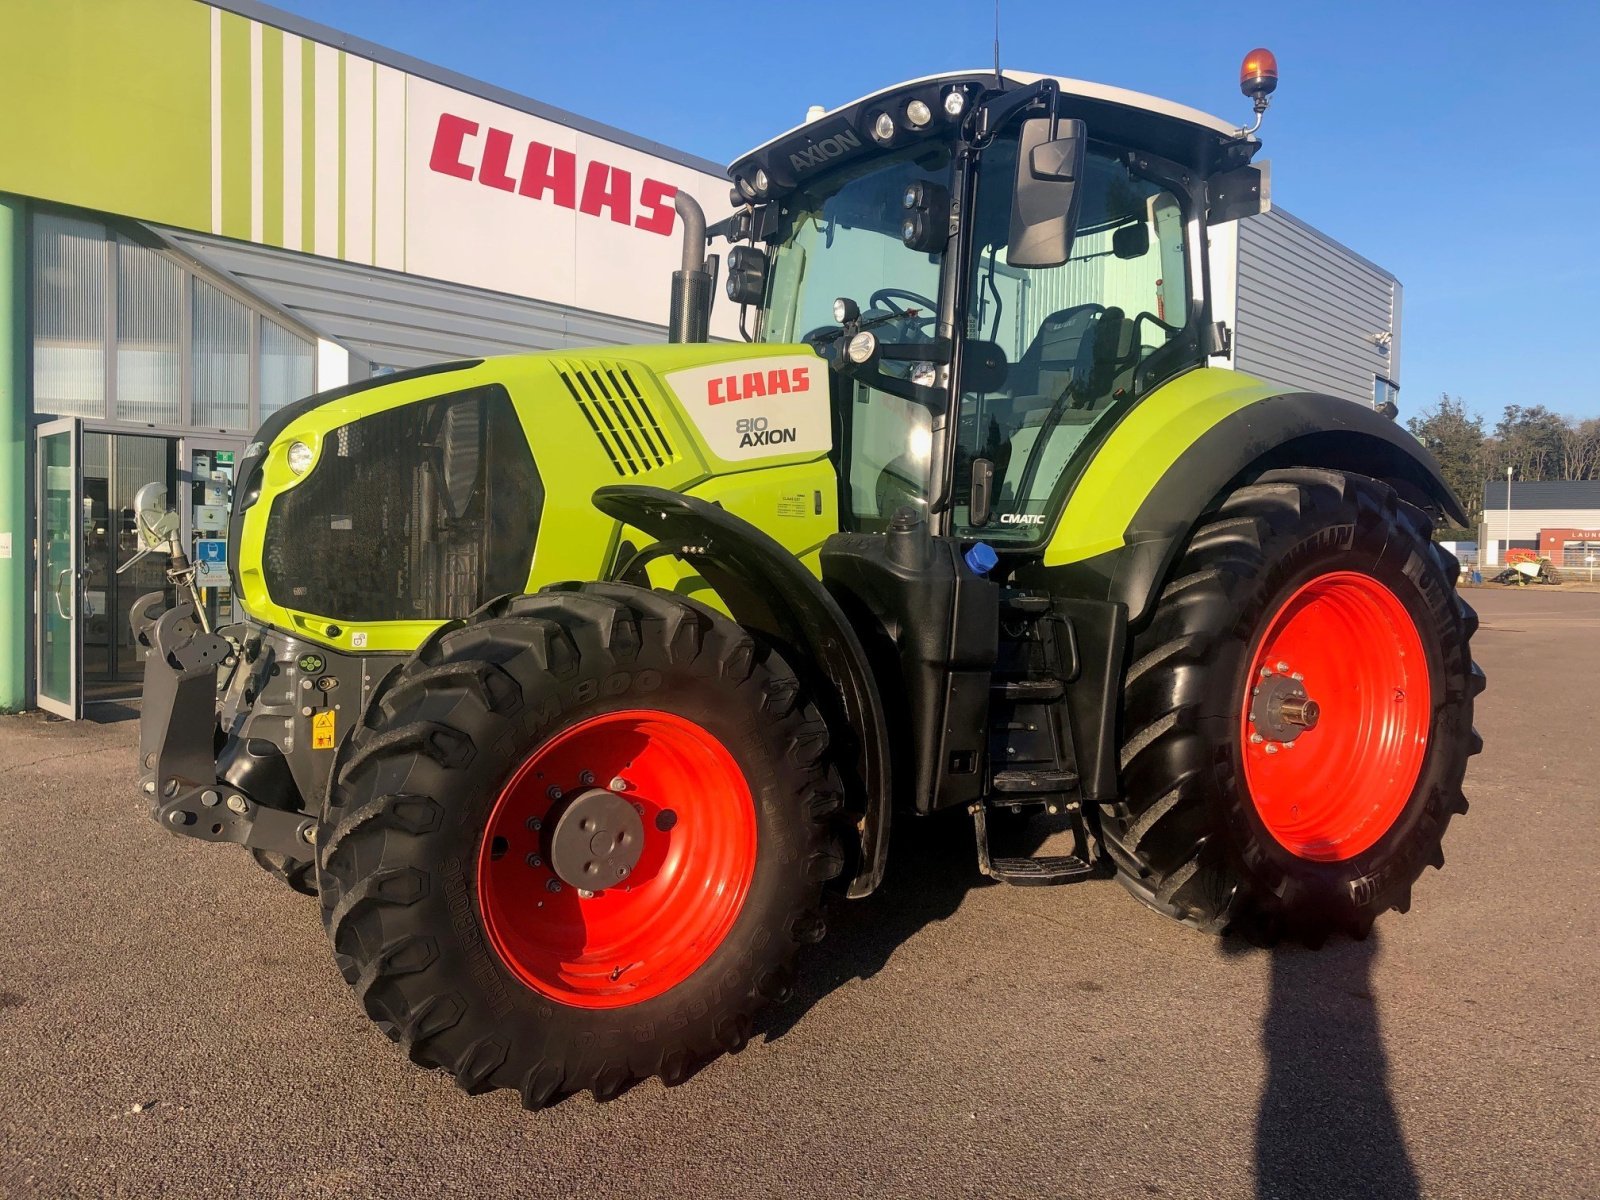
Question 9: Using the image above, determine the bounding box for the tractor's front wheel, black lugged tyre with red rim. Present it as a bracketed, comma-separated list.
[318, 584, 848, 1109]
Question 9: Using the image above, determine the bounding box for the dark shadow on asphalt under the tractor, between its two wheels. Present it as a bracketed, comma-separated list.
[755, 810, 987, 1042]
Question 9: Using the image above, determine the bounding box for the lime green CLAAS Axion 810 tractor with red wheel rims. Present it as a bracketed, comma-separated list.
[133, 58, 1483, 1107]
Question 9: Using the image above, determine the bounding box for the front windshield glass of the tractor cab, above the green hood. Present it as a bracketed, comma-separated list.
[760, 144, 950, 342]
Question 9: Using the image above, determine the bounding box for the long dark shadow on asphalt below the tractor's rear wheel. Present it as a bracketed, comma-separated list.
[1222, 934, 1422, 1200]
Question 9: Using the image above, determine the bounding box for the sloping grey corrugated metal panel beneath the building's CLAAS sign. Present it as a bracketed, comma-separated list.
[158, 229, 669, 368]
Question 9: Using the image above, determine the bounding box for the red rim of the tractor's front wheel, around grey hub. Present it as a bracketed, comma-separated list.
[478, 709, 755, 1008]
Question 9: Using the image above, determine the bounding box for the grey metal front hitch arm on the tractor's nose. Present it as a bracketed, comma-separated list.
[128, 587, 317, 858]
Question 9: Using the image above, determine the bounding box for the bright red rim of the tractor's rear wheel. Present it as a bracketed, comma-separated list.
[1240, 571, 1434, 862]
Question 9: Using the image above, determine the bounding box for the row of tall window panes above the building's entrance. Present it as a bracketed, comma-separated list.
[30, 210, 317, 434]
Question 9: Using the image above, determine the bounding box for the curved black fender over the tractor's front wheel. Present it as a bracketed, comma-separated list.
[594, 483, 891, 898]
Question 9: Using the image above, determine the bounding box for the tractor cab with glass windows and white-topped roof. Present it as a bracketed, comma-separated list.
[723, 72, 1267, 547]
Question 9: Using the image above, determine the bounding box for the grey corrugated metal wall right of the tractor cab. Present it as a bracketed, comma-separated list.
[1234, 210, 1400, 405]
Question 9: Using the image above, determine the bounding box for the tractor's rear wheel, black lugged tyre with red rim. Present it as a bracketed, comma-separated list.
[1101, 469, 1483, 946]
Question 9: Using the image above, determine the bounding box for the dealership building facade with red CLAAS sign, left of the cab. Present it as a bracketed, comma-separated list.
[0, 0, 734, 717]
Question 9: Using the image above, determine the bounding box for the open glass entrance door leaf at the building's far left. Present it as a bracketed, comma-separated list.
[34, 418, 83, 720]
